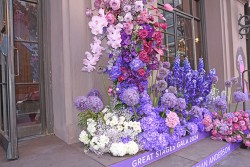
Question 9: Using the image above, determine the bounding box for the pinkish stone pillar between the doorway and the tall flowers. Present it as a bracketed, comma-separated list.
[50, 0, 101, 144]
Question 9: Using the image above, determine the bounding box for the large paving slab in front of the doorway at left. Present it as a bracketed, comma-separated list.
[0, 136, 104, 167]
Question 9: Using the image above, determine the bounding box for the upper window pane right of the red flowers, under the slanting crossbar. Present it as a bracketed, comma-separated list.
[177, 16, 192, 38]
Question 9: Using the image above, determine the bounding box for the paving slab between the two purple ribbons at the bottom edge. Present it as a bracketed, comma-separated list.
[147, 154, 197, 167]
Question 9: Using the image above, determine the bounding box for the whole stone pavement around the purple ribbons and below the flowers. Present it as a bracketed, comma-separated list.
[0, 135, 250, 167]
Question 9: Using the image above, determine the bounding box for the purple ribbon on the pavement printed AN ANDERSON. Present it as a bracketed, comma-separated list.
[193, 143, 240, 167]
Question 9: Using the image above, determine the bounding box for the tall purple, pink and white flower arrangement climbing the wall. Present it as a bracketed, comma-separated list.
[75, 0, 219, 156]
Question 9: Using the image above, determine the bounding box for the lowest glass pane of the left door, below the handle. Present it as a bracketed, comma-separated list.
[16, 85, 41, 127]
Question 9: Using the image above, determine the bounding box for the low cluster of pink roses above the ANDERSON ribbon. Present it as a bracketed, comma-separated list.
[202, 111, 250, 147]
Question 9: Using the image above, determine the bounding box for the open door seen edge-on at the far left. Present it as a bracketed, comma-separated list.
[0, 0, 18, 159]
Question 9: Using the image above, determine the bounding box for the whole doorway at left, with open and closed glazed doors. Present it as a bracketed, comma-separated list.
[0, 0, 46, 159]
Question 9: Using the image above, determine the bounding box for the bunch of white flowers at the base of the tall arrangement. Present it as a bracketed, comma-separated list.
[79, 108, 142, 156]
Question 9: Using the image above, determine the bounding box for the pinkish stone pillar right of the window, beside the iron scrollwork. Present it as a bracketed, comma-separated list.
[205, 0, 247, 90]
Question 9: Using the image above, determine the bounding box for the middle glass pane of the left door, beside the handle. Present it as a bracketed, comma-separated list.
[15, 42, 40, 83]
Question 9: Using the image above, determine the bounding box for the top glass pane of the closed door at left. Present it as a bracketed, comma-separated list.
[14, 0, 38, 41]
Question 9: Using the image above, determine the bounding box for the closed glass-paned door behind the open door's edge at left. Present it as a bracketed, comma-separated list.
[13, 0, 42, 138]
